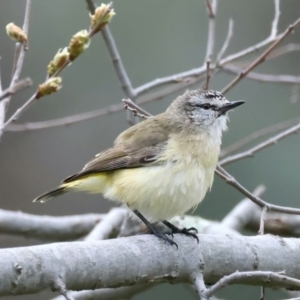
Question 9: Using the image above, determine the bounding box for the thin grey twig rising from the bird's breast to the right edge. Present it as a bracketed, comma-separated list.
[219, 123, 300, 166]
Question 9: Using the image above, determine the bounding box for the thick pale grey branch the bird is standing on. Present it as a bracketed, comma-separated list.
[0, 235, 300, 296]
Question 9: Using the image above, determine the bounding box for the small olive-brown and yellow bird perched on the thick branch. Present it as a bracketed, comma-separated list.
[33, 90, 244, 247]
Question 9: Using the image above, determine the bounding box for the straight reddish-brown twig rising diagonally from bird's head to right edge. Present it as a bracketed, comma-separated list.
[222, 18, 300, 94]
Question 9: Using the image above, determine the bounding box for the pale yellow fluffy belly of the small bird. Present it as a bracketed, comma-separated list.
[104, 163, 214, 221]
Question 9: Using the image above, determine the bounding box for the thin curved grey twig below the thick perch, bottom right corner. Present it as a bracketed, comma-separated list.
[205, 271, 300, 297]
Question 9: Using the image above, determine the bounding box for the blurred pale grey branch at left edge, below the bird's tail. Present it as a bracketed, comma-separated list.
[0, 209, 105, 241]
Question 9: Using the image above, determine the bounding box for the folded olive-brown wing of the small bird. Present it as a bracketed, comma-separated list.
[63, 116, 168, 183]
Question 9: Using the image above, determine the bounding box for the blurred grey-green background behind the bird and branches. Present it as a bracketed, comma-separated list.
[0, 0, 300, 300]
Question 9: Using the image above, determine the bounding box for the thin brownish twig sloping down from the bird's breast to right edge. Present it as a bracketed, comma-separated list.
[216, 165, 300, 215]
